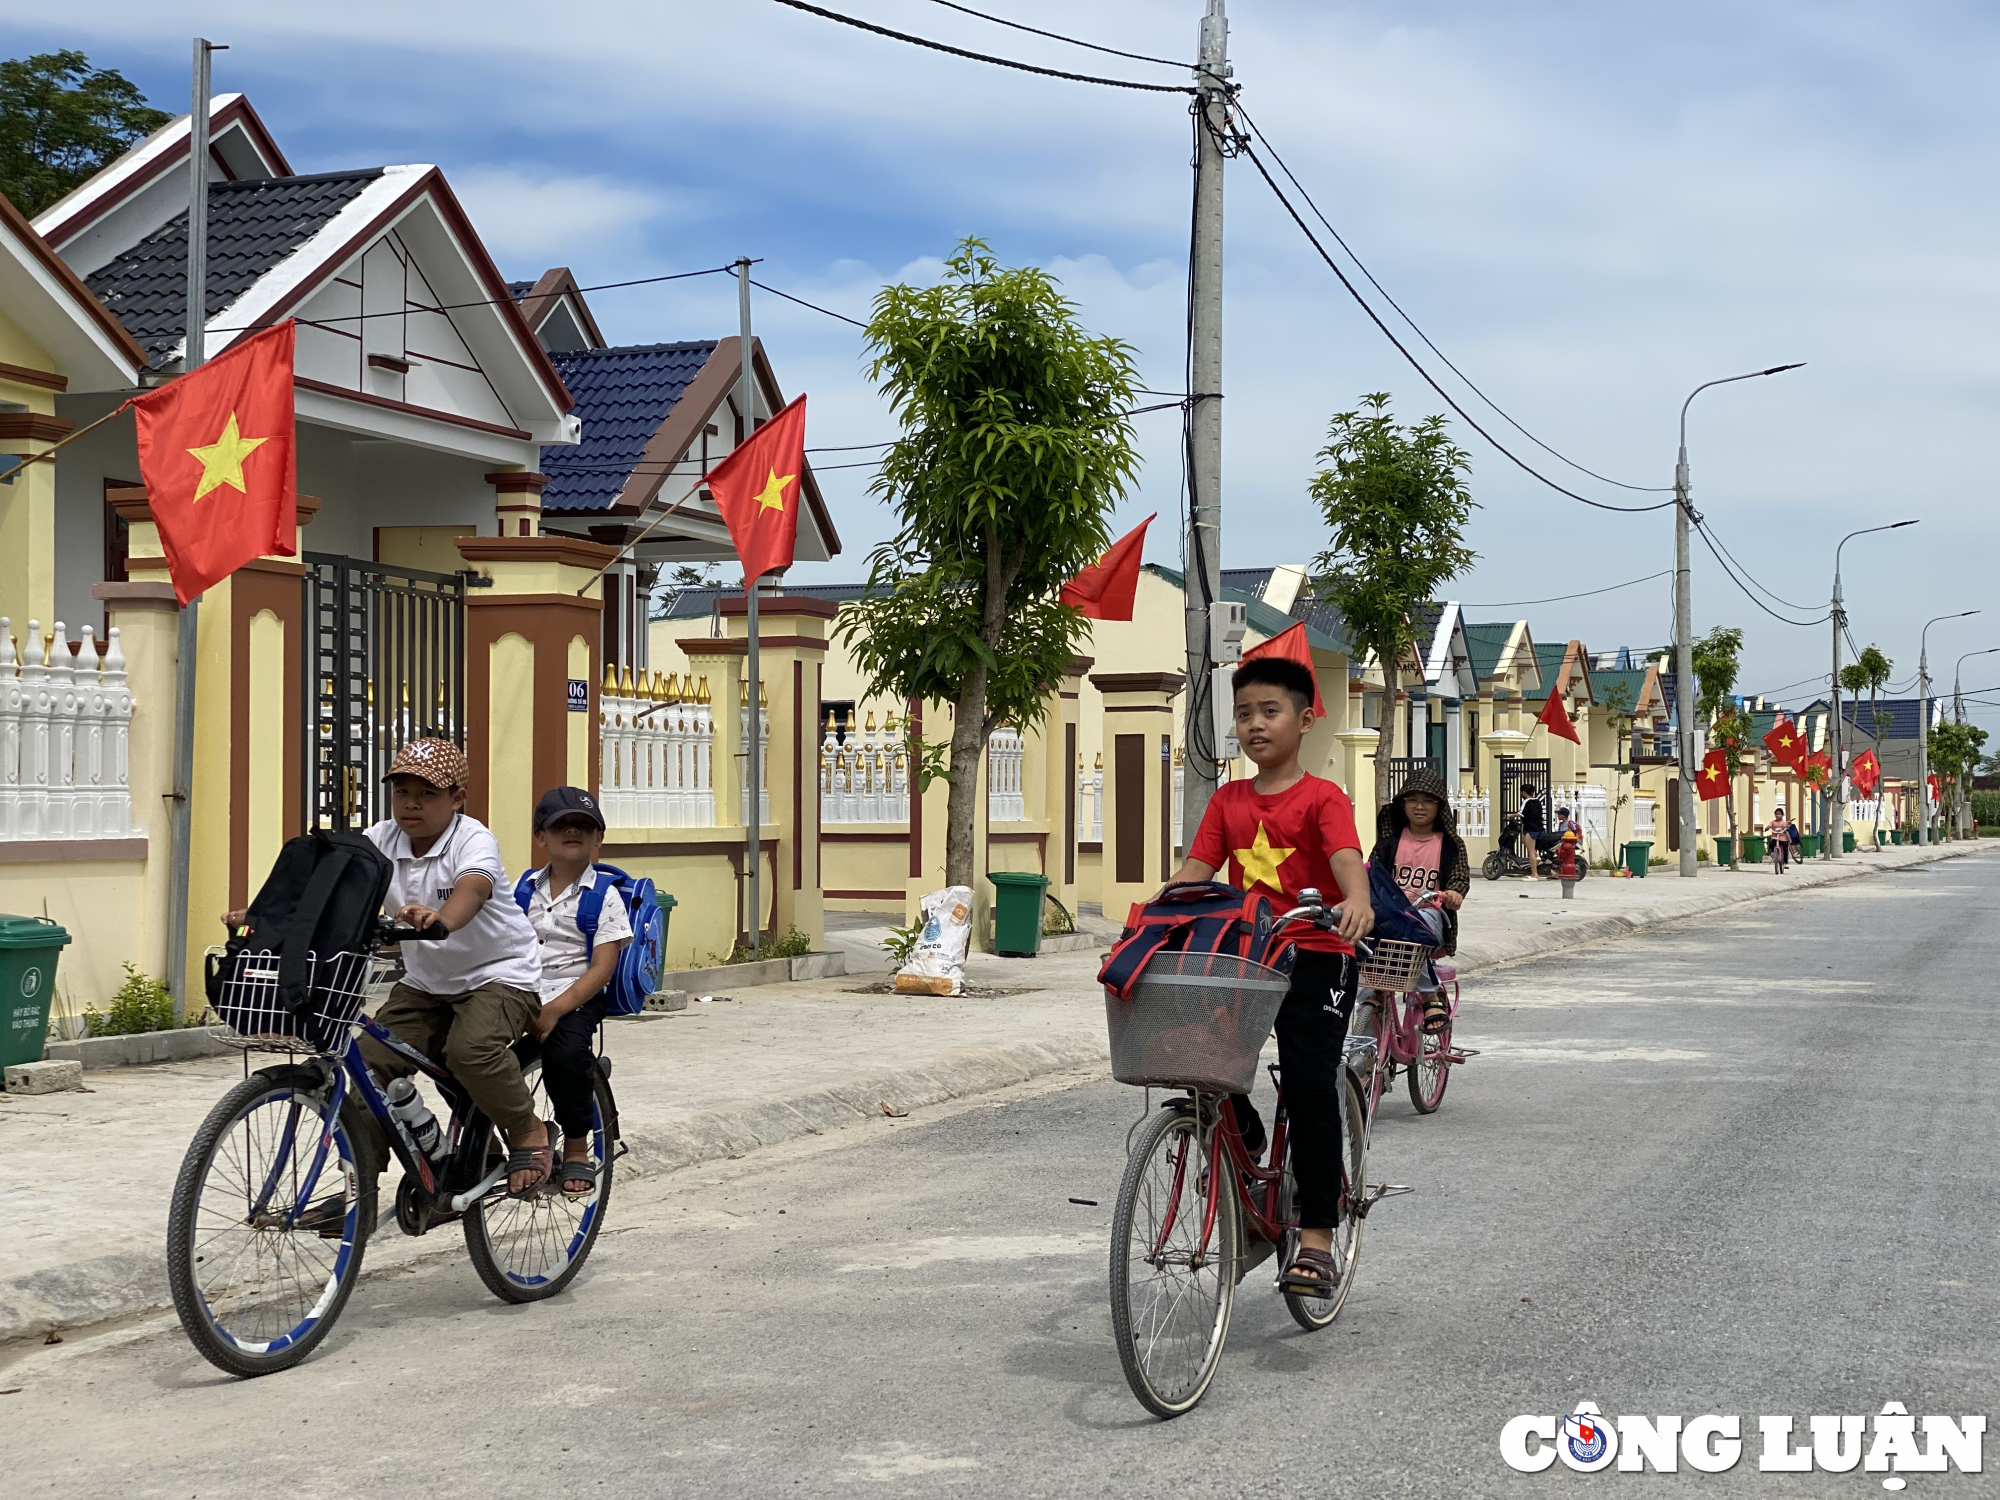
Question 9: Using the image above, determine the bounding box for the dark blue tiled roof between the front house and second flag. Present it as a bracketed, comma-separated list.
[542, 338, 716, 514]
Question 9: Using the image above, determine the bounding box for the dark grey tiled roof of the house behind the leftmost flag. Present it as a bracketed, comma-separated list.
[84, 166, 382, 368]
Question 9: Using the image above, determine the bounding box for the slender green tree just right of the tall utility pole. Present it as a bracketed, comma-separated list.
[1310, 390, 1478, 806]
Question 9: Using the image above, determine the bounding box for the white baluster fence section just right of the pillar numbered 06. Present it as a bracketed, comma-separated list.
[598, 674, 716, 828]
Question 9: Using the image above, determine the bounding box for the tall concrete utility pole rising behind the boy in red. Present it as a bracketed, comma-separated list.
[1182, 0, 1230, 842]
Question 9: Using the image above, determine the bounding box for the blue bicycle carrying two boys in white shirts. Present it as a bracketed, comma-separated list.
[166, 924, 624, 1376]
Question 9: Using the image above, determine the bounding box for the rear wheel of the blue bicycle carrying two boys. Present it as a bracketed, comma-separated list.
[464, 1062, 616, 1302]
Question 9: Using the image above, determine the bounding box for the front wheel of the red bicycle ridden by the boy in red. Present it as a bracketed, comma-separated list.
[1110, 1106, 1236, 1416]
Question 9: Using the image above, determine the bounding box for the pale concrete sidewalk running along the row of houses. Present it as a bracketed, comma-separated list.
[0, 844, 1994, 1340]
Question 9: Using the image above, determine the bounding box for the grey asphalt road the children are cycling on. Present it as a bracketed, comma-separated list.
[0, 858, 2000, 1500]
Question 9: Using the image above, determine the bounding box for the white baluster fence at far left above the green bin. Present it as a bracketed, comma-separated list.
[0, 616, 134, 838]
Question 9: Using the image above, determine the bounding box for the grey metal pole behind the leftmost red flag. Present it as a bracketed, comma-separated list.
[166, 36, 214, 1026]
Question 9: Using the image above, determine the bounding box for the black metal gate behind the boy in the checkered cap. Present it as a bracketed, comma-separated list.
[300, 552, 466, 832]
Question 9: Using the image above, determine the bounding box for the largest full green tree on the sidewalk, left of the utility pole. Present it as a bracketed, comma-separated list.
[840, 240, 1138, 886]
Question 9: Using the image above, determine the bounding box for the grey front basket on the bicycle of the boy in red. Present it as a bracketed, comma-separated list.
[1104, 954, 1290, 1094]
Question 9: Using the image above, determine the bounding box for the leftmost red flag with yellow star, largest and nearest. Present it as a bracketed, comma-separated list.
[132, 322, 298, 604]
